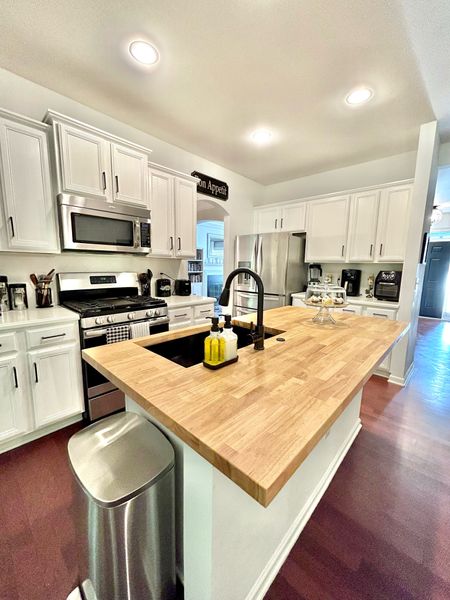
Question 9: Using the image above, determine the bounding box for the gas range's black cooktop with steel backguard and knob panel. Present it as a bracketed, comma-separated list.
[58, 273, 168, 329]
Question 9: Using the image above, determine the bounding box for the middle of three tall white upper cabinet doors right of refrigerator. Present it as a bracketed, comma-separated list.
[347, 191, 380, 262]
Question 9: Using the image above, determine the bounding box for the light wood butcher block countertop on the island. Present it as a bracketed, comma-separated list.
[83, 306, 408, 506]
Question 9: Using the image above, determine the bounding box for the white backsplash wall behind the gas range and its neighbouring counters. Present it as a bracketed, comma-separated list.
[0, 252, 186, 308]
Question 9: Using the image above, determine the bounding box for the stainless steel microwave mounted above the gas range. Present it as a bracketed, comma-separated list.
[57, 194, 151, 254]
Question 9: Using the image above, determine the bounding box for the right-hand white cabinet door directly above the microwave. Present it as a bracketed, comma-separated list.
[111, 144, 149, 208]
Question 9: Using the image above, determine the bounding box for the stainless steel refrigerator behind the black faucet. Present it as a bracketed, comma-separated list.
[233, 233, 307, 315]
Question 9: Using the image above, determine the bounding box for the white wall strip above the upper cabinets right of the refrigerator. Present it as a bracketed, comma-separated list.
[256, 151, 418, 205]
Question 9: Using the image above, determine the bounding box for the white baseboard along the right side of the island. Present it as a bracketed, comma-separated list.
[245, 419, 361, 600]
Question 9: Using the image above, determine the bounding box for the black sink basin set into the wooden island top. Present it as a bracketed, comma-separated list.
[145, 325, 278, 368]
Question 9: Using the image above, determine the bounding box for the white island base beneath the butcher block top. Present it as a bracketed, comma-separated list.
[126, 392, 361, 600]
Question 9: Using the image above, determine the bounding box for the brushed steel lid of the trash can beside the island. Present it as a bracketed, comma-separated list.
[68, 412, 174, 506]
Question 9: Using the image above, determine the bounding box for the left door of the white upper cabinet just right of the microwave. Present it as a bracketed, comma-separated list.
[148, 169, 175, 256]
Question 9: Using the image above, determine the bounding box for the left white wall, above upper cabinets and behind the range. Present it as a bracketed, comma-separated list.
[0, 69, 263, 296]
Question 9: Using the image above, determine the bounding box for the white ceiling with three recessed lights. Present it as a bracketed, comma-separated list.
[0, 0, 442, 184]
